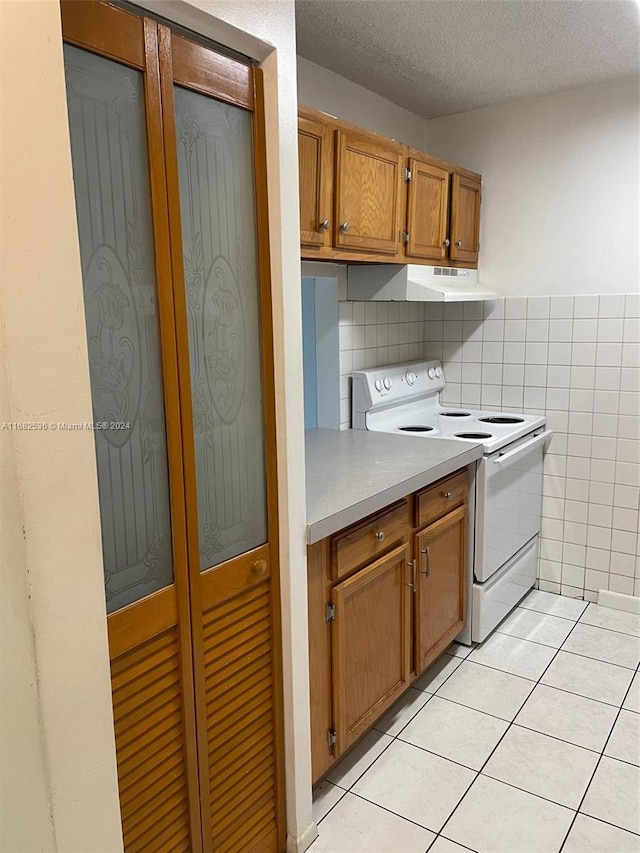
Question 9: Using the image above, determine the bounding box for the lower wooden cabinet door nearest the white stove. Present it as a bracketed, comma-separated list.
[415, 505, 467, 673]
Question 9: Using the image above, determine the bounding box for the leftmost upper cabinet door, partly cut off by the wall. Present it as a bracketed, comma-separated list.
[298, 116, 333, 248]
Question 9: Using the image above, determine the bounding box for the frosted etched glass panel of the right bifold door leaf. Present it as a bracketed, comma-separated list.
[175, 86, 267, 571]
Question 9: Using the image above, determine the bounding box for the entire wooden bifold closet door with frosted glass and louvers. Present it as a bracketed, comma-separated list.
[62, 0, 285, 853]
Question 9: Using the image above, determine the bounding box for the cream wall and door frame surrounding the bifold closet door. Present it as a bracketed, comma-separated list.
[0, 0, 315, 853]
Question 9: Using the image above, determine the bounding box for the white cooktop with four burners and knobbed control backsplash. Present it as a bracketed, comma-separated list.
[352, 361, 545, 454]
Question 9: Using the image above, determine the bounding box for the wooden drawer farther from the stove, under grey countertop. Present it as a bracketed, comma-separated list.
[331, 500, 410, 580]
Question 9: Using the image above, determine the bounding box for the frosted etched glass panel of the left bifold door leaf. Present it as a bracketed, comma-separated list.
[64, 44, 173, 612]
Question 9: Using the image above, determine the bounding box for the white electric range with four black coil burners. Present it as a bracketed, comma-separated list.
[352, 360, 552, 642]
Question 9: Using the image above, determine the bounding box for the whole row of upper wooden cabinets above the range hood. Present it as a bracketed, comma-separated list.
[298, 107, 481, 267]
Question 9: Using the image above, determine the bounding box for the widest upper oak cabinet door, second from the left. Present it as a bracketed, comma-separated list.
[334, 131, 402, 255]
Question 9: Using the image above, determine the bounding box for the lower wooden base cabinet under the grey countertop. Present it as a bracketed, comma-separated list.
[308, 469, 468, 782]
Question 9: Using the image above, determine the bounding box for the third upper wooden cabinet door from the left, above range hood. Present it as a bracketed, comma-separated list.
[405, 159, 449, 260]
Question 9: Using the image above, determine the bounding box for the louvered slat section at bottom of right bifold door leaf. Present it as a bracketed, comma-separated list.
[203, 581, 277, 853]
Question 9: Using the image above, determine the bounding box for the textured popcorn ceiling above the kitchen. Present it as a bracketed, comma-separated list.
[296, 0, 640, 118]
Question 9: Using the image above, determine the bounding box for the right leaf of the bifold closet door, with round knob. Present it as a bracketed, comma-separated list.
[160, 28, 285, 853]
